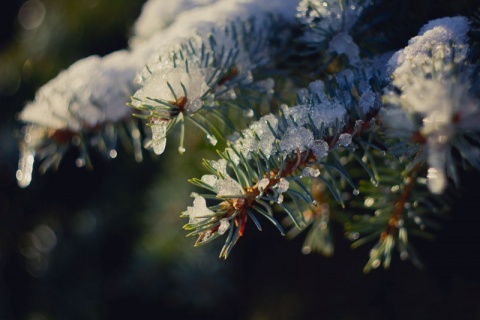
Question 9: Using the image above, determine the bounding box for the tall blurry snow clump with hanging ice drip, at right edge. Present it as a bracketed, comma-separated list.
[381, 17, 480, 194]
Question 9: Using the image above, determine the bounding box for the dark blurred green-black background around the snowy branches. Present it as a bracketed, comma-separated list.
[0, 0, 480, 320]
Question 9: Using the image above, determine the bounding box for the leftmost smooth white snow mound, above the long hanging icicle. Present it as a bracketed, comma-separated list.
[19, 51, 135, 132]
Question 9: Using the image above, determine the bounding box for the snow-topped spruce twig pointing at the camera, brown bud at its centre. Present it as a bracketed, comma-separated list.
[131, 16, 292, 154]
